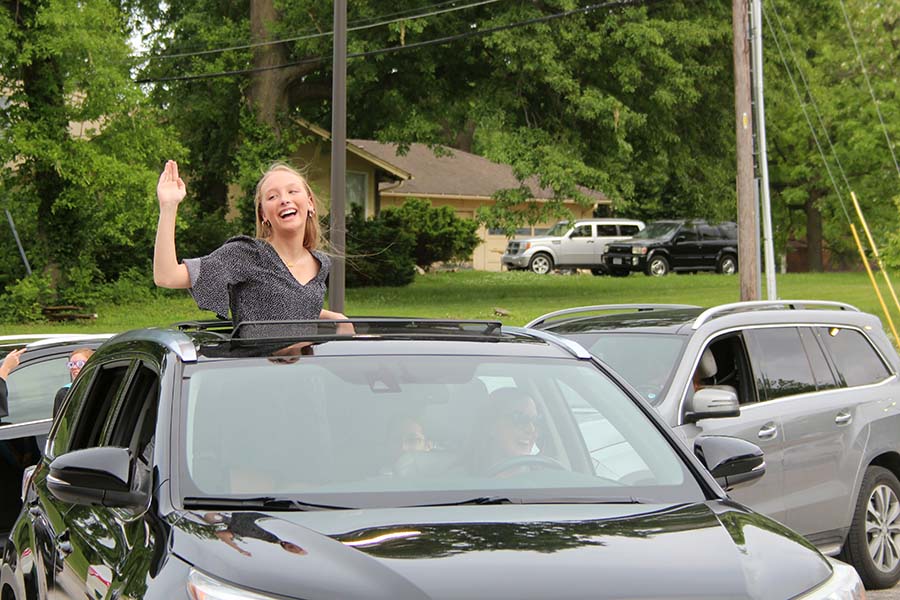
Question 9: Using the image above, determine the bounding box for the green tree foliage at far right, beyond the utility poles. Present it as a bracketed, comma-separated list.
[764, 0, 900, 270]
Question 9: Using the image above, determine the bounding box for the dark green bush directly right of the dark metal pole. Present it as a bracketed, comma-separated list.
[346, 206, 415, 288]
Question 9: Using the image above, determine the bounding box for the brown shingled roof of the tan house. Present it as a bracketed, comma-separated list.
[347, 140, 609, 203]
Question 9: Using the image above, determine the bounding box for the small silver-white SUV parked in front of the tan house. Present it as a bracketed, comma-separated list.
[501, 219, 644, 275]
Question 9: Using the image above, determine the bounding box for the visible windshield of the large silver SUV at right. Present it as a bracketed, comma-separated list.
[566, 332, 685, 404]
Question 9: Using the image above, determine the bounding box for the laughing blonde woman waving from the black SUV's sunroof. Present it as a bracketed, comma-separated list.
[153, 160, 352, 336]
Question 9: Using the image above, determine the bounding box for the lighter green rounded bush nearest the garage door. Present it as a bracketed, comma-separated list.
[379, 198, 481, 270]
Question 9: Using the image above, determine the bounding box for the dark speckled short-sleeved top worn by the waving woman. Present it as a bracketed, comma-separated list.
[184, 235, 331, 337]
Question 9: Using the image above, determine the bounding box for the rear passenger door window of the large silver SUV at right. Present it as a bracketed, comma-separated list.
[745, 327, 816, 400]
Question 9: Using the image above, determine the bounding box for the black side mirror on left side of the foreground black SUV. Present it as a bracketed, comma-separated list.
[47, 447, 150, 509]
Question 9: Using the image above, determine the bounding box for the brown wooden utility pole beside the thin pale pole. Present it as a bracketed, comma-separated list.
[731, 0, 760, 300]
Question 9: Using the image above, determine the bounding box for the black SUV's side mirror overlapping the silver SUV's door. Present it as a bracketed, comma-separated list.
[694, 435, 766, 491]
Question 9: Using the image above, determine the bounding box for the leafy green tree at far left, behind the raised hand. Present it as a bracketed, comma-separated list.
[0, 0, 182, 300]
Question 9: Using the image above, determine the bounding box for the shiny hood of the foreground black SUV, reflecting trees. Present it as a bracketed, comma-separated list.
[172, 501, 831, 600]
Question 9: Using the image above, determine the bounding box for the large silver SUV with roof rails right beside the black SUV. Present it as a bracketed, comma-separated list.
[528, 300, 900, 588]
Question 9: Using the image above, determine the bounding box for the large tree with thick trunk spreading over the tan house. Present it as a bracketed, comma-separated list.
[134, 0, 734, 244]
